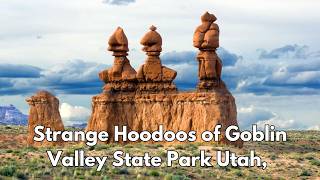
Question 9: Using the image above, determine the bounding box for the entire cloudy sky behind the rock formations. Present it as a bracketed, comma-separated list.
[0, 0, 320, 129]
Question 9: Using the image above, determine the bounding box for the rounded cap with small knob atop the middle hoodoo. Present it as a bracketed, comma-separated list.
[140, 25, 162, 52]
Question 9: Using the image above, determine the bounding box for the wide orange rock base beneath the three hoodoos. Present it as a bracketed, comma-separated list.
[86, 83, 242, 147]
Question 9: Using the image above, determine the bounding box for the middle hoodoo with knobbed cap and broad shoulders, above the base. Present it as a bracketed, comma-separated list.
[137, 26, 177, 92]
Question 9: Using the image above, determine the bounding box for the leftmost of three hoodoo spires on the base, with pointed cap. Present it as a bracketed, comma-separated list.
[99, 27, 136, 92]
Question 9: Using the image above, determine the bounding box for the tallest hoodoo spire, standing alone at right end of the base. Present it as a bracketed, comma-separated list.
[193, 12, 223, 91]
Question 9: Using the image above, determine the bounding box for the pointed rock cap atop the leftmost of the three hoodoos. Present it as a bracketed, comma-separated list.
[108, 27, 129, 52]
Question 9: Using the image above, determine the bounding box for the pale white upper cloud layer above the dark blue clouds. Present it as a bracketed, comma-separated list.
[0, 0, 320, 68]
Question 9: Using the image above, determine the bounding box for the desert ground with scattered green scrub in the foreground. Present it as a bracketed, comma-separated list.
[0, 126, 320, 180]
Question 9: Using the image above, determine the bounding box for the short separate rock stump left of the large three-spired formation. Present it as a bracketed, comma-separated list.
[26, 91, 64, 146]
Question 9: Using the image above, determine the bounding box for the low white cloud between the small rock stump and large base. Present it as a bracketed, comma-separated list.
[59, 103, 91, 126]
